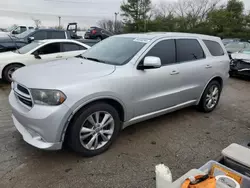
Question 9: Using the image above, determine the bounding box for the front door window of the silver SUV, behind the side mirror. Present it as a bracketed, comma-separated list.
[146, 40, 175, 65]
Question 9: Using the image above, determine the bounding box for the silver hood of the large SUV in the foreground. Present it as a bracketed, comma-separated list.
[13, 58, 115, 89]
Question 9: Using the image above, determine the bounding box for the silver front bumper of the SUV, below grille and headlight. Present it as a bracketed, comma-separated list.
[9, 91, 71, 150]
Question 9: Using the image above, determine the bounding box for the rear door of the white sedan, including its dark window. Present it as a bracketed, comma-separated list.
[61, 42, 87, 58]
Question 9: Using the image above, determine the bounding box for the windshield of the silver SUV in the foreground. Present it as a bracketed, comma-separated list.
[82, 37, 148, 65]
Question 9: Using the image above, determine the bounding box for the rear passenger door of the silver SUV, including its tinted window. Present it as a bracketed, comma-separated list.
[176, 38, 214, 103]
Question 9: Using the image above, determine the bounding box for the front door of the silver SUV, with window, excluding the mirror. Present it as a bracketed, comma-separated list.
[133, 39, 180, 116]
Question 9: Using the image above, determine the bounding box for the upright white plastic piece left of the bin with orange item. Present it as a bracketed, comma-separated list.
[155, 164, 173, 188]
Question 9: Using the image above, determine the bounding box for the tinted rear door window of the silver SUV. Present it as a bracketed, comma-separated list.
[176, 39, 205, 62]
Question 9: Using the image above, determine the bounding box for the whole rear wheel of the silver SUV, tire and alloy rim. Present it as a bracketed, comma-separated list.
[198, 80, 221, 113]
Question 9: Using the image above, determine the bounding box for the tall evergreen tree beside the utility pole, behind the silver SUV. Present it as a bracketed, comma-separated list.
[120, 0, 151, 32]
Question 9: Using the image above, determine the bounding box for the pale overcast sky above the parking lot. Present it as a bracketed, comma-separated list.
[0, 0, 250, 27]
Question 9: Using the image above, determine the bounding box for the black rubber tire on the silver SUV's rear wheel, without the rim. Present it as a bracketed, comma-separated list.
[198, 80, 222, 113]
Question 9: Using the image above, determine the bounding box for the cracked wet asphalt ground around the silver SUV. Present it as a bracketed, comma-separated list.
[0, 78, 250, 188]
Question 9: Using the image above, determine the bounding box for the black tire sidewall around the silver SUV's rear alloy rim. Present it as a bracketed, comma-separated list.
[200, 81, 222, 113]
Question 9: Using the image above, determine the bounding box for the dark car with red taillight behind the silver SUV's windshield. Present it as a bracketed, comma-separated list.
[84, 27, 113, 40]
